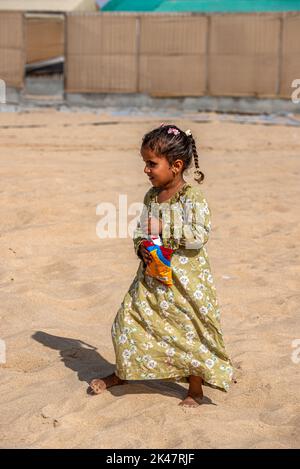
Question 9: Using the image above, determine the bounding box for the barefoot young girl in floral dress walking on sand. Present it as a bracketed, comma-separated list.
[90, 124, 233, 407]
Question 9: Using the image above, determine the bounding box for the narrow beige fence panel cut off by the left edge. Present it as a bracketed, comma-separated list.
[0, 12, 25, 88]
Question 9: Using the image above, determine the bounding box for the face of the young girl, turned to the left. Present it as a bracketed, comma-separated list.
[141, 147, 179, 187]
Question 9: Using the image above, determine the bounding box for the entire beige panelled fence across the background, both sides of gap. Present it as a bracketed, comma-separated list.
[0, 12, 300, 99]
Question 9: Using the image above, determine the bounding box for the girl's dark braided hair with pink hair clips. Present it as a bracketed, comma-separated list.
[142, 124, 204, 184]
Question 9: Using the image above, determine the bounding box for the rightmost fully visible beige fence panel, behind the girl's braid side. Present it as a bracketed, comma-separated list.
[208, 14, 280, 97]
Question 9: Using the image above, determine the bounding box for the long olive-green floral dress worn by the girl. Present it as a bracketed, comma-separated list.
[111, 183, 233, 391]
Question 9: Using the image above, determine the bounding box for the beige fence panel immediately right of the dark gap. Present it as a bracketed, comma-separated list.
[65, 14, 138, 93]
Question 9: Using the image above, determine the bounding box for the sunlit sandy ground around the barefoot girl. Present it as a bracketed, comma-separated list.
[0, 110, 300, 448]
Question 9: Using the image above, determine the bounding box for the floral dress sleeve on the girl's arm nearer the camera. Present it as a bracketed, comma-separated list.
[162, 190, 211, 250]
